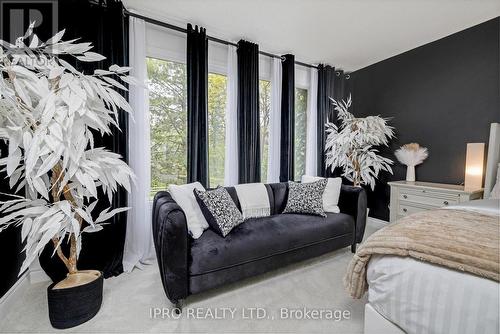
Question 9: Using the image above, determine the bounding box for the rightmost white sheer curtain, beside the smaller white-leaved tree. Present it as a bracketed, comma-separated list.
[306, 68, 323, 176]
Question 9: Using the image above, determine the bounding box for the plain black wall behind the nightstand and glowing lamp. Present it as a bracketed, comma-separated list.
[351, 17, 500, 220]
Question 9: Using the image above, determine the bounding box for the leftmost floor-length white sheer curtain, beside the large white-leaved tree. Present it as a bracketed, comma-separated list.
[123, 17, 155, 272]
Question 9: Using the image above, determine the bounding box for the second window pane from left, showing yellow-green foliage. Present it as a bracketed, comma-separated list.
[208, 73, 227, 187]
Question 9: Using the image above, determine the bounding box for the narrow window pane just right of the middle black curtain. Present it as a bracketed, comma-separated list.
[259, 80, 271, 182]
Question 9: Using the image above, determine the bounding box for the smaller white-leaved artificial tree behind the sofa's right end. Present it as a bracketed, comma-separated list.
[325, 95, 394, 190]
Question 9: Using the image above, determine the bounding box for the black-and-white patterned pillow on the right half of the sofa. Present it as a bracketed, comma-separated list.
[283, 179, 328, 217]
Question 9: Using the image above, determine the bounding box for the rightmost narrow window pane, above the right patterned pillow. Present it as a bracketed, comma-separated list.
[294, 88, 307, 181]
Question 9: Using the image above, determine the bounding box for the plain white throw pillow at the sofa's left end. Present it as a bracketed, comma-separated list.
[168, 182, 208, 239]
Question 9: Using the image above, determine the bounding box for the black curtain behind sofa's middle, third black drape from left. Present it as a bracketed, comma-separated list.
[237, 40, 260, 183]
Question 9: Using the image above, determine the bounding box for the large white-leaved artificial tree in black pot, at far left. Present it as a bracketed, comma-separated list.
[0, 24, 134, 328]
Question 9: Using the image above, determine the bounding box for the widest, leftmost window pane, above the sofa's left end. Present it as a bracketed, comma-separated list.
[147, 58, 187, 195]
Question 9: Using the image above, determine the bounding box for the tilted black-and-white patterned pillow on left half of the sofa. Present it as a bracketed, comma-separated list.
[194, 186, 243, 237]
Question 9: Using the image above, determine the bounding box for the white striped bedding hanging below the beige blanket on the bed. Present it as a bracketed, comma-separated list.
[367, 256, 500, 334]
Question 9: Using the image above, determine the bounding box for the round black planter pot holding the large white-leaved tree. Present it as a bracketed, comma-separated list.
[47, 273, 104, 329]
